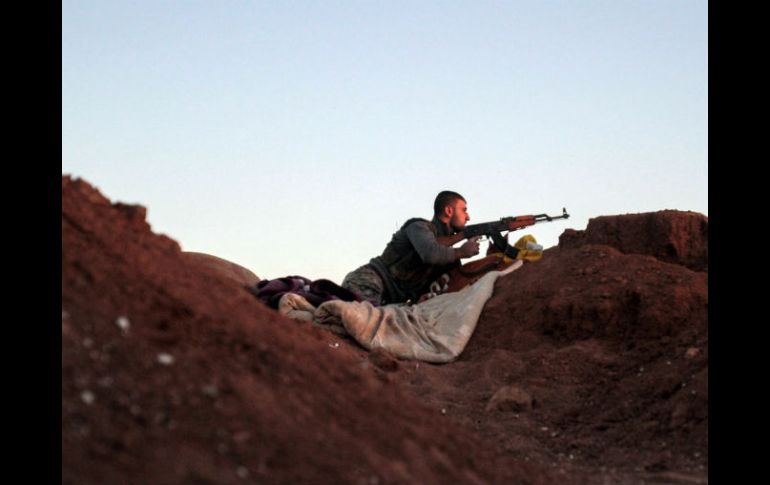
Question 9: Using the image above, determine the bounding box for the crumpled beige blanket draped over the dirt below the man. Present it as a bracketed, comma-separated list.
[279, 261, 522, 363]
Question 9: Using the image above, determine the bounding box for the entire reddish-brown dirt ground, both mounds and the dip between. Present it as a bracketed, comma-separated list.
[61, 176, 709, 485]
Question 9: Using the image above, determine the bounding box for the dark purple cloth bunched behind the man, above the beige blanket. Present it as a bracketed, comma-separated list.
[250, 276, 361, 308]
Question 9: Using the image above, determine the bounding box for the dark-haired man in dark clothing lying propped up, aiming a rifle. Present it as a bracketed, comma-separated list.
[342, 190, 479, 306]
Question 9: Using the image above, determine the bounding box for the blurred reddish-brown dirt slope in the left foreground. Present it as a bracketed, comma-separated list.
[62, 177, 552, 484]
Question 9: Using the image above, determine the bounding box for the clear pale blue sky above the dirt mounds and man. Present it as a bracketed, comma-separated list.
[62, 0, 708, 283]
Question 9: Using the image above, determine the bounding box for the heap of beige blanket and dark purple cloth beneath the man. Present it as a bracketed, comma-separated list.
[252, 260, 524, 364]
